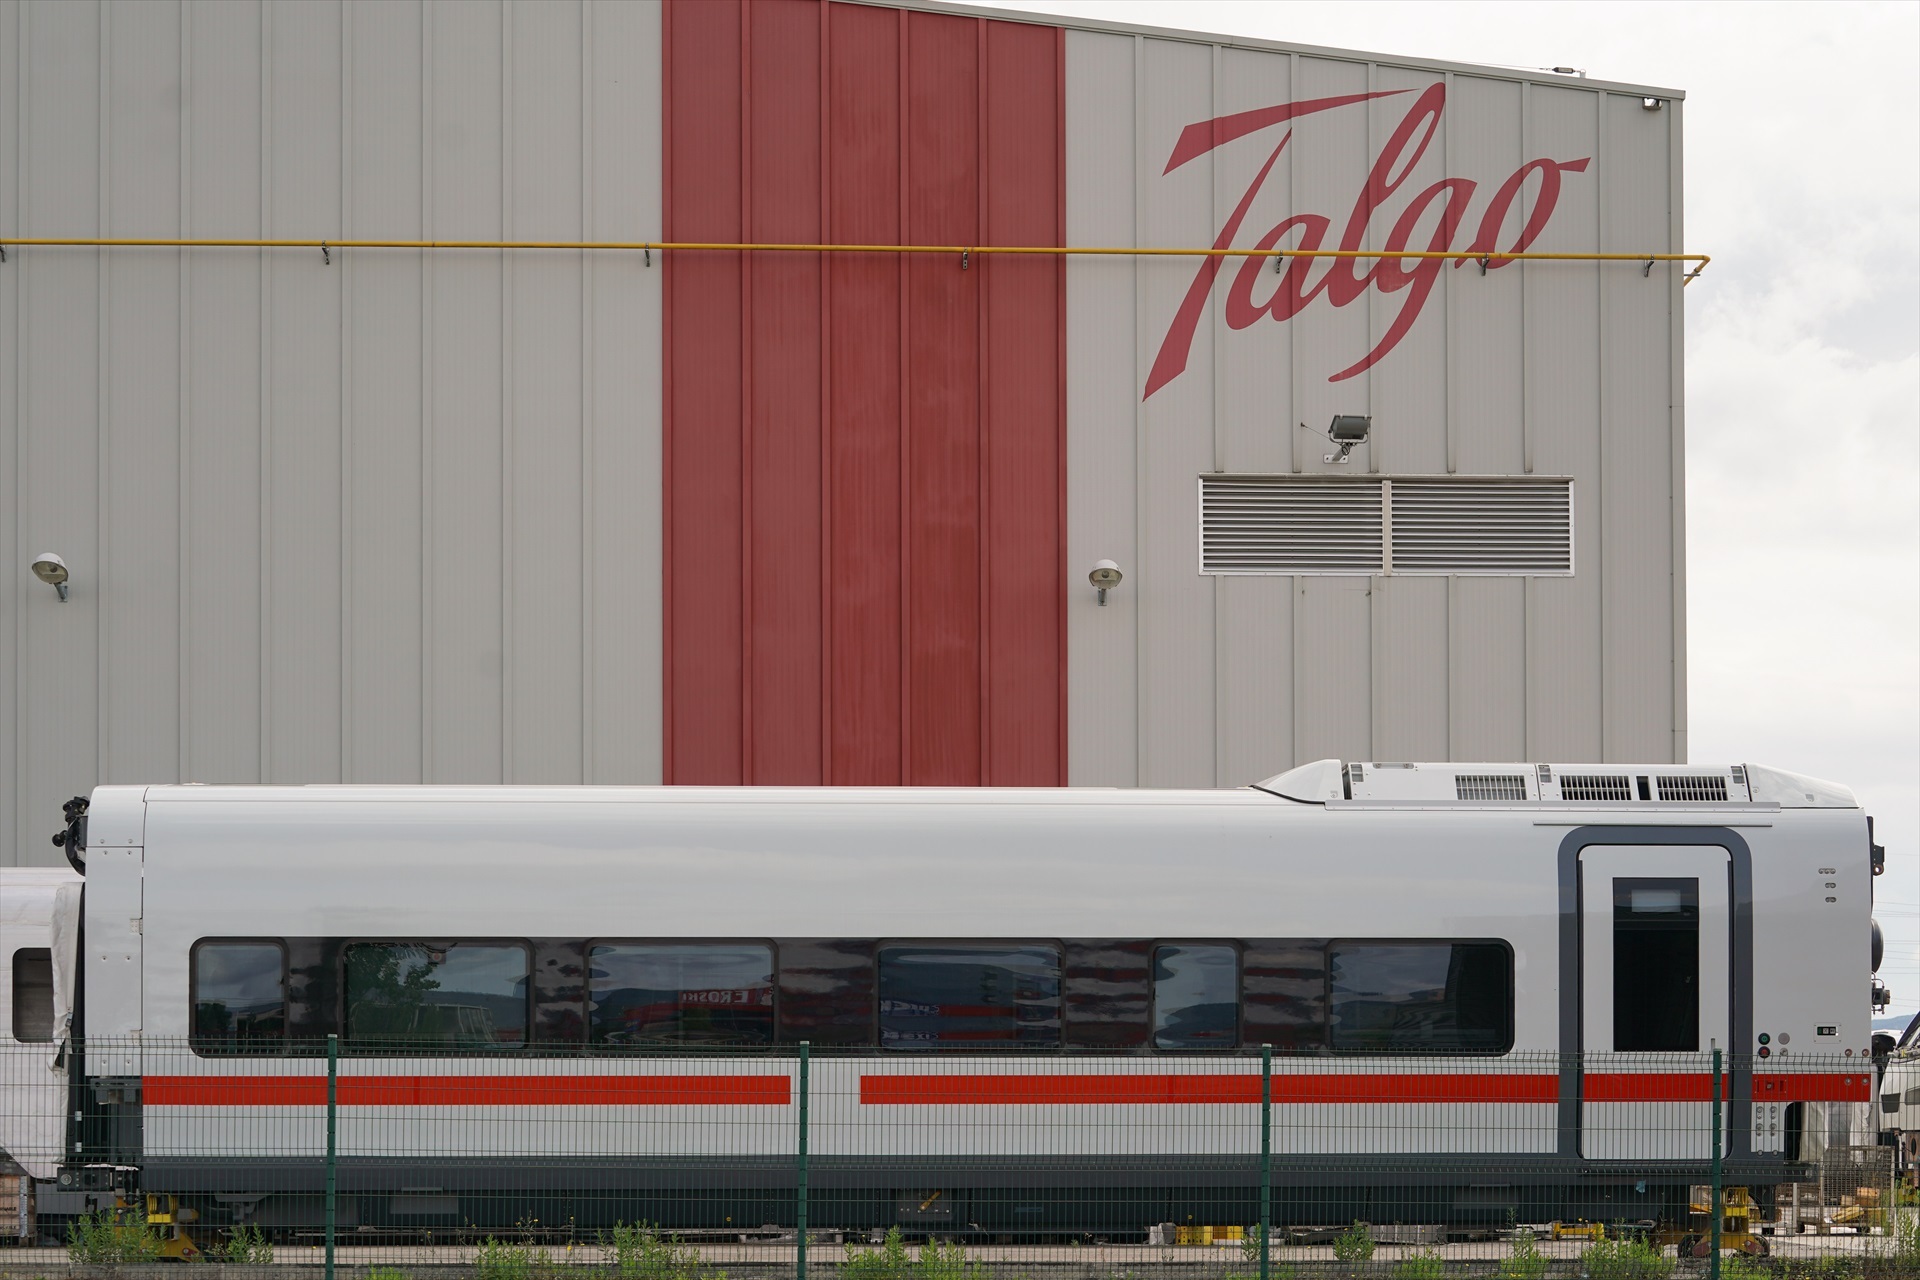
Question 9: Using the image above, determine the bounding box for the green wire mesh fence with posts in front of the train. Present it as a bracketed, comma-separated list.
[0, 1040, 1920, 1280]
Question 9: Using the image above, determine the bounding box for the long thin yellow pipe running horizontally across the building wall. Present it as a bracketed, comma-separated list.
[0, 236, 1713, 282]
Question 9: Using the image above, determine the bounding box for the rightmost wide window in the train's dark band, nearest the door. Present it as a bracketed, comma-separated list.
[1327, 942, 1513, 1054]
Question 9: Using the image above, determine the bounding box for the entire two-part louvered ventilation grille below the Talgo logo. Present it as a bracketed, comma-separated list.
[1200, 476, 1572, 576]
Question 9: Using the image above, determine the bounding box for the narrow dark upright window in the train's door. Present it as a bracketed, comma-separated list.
[1613, 879, 1699, 1054]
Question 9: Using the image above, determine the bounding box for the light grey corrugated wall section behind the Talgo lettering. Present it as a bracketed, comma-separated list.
[1066, 31, 1686, 787]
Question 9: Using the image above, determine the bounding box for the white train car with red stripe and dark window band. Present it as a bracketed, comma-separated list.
[0, 760, 1878, 1230]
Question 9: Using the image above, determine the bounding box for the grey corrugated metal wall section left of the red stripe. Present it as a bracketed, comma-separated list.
[0, 0, 660, 862]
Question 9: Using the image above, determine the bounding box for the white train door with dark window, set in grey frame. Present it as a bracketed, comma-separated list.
[1580, 844, 1732, 1159]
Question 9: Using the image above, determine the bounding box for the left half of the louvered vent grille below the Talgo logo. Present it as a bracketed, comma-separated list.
[1200, 476, 1382, 574]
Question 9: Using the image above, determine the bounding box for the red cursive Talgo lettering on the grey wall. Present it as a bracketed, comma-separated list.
[1140, 83, 1592, 399]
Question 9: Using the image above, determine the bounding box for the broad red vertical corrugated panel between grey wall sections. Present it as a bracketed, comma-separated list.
[664, 0, 1066, 785]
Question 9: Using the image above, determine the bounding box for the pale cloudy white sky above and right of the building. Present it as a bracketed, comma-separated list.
[985, 0, 1920, 1009]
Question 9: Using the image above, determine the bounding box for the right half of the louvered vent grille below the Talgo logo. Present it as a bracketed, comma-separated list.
[1392, 480, 1572, 574]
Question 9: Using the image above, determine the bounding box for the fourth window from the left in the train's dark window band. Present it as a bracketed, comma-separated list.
[879, 944, 1060, 1050]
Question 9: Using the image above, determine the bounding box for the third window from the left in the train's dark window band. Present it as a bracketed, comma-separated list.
[588, 942, 774, 1046]
